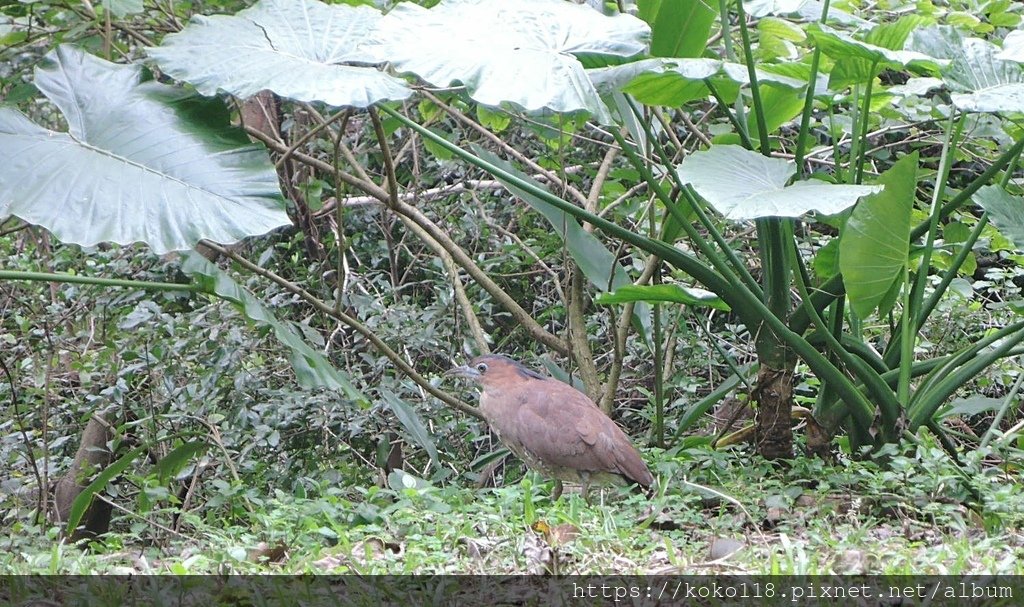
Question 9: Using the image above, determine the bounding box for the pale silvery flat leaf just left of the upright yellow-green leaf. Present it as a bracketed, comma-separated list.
[676, 145, 882, 221]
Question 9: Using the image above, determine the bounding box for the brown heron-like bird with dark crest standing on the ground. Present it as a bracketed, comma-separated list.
[447, 354, 654, 502]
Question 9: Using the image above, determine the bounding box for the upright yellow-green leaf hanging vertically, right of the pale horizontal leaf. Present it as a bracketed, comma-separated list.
[839, 151, 918, 318]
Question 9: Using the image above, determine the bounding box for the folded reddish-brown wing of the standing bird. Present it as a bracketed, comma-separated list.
[514, 380, 653, 486]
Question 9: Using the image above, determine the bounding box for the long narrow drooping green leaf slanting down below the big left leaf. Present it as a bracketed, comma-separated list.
[181, 252, 367, 401]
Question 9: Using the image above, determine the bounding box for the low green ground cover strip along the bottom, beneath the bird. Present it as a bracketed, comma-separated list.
[0, 436, 1024, 574]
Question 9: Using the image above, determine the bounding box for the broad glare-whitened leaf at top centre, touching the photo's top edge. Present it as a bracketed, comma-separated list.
[377, 0, 650, 123]
